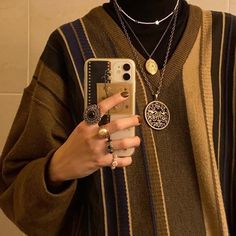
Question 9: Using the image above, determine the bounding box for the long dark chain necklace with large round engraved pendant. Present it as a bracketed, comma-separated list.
[113, 0, 179, 130]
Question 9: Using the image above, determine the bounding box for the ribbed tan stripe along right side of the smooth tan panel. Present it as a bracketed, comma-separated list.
[200, 12, 228, 235]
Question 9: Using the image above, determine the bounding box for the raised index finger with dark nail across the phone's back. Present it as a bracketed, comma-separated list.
[98, 91, 129, 116]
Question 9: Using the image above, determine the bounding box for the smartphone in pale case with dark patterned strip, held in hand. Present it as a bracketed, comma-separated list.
[84, 58, 136, 156]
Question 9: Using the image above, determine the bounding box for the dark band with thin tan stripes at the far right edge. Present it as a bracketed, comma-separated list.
[212, 12, 236, 235]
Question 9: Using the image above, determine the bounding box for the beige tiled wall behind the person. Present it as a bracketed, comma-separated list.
[0, 0, 236, 236]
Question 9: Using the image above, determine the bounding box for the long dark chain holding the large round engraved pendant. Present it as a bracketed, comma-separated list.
[114, 1, 179, 100]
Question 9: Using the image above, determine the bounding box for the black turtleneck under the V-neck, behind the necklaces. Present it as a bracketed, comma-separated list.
[103, 0, 189, 68]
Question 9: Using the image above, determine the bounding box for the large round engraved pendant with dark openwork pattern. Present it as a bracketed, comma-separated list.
[144, 100, 170, 130]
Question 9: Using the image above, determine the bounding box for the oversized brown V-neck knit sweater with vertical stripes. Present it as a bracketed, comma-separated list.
[0, 6, 236, 236]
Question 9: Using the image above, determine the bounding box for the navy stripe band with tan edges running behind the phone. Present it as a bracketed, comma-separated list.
[60, 20, 132, 236]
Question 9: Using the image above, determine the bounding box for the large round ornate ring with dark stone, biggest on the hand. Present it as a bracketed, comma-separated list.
[84, 104, 101, 125]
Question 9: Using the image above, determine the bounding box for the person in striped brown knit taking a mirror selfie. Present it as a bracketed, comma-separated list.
[0, 0, 236, 236]
